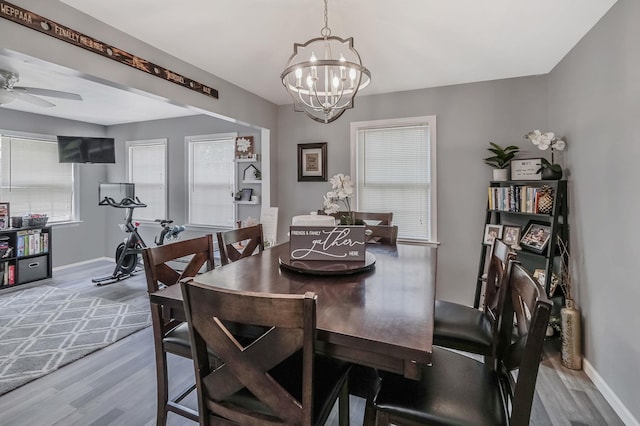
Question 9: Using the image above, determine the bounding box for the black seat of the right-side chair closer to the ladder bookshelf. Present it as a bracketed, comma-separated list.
[433, 300, 493, 355]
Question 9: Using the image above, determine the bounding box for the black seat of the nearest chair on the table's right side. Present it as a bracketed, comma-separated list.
[374, 347, 507, 425]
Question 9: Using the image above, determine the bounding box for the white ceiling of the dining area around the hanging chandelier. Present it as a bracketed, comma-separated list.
[0, 0, 616, 125]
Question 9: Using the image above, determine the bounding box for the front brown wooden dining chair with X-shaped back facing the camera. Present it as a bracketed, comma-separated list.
[181, 281, 350, 426]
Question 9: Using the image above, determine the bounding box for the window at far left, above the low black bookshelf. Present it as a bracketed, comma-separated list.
[0, 135, 76, 223]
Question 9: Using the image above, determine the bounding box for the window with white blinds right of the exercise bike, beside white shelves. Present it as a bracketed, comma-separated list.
[187, 133, 237, 228]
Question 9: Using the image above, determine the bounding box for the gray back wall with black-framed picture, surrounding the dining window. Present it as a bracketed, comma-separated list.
[277, 76, 547, 303]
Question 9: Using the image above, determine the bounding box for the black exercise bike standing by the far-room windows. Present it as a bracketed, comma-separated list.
[91, 197, 185, 286]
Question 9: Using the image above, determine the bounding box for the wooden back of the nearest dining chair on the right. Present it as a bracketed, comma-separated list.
[498, 262, 552, 425]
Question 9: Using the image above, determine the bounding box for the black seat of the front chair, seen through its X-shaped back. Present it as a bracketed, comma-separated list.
[204, 351, 351, 425]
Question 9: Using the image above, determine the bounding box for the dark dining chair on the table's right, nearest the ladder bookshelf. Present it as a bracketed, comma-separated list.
[433, 239, 514, 362]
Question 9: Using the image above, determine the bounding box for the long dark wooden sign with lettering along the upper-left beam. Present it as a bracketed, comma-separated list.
[0, 1, 218, 99]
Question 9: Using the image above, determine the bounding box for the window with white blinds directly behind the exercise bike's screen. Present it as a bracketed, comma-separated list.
[127, 139, 167, 221]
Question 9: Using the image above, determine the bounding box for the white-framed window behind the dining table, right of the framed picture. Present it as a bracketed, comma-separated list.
[351, 116, 436, 242]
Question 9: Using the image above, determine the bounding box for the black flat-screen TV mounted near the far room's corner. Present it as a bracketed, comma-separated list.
[58, 136, 116, 163]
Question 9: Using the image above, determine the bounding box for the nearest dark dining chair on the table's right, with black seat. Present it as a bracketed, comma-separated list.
[374, 262, 552, 426]
